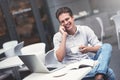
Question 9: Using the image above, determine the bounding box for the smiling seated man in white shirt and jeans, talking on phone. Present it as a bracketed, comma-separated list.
[53, 7, 115, 80]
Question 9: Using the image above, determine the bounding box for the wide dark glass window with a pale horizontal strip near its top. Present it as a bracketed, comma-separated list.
[9, 0, 40, 45]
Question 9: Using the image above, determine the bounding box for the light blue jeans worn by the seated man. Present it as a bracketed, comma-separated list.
[86, 43, 116, 80]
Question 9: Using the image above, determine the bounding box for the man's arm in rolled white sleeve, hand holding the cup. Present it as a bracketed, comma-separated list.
[79, 26, 102, 53]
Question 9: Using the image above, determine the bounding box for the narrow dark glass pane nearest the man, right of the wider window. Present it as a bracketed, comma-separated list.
[36, 0, 54, 48]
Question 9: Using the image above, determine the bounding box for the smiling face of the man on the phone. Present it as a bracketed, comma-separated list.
[58, 13, 74, 31]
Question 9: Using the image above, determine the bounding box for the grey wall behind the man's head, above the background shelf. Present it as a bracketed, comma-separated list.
[47, 0, 120, 32]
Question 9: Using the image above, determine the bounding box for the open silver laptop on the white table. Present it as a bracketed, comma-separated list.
[19, 55, 64, 73]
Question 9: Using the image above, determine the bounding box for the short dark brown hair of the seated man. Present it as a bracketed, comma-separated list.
[56, 7, 73, 19]
